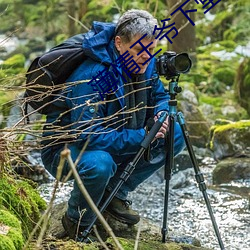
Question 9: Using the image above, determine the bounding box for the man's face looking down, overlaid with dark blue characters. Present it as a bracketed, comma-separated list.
[115, 35, 157, 74]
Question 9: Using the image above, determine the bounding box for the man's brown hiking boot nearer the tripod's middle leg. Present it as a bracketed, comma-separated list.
[105, 197, 140, 225]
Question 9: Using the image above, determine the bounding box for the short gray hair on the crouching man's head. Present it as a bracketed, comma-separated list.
[116, 9, 158, 43]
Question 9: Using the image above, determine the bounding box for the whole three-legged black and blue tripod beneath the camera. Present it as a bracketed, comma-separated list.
[82, 77, 225, 250]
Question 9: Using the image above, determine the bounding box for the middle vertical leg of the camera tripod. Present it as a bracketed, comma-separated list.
[161, 114, 175, 243]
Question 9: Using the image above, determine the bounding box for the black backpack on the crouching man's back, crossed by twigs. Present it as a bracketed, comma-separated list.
[24, 34, 86, 114]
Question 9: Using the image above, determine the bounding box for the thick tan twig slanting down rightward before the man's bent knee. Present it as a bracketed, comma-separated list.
[61, 149, 124, 250]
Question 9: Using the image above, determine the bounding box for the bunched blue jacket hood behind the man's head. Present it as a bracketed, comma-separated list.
[82, 21, 116, 64]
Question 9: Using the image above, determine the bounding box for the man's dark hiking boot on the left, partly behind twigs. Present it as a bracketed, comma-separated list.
[62, 213, 97, 243]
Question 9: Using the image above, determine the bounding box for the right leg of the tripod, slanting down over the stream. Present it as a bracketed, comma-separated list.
[177, 112, 225, 250]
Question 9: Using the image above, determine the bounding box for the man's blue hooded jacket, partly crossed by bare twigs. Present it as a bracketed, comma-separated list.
[44, 22, 169, 155]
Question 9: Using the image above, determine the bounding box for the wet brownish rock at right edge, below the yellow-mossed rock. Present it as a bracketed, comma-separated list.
[213, 157, 250, 184]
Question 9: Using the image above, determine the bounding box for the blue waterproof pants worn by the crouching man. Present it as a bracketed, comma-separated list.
[42, 123, 185, 226]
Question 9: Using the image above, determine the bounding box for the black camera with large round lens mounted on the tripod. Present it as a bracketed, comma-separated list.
[156, 51, 192, 80]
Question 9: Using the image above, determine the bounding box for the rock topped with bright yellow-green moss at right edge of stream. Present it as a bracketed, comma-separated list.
[209, 120, 250, 159]
